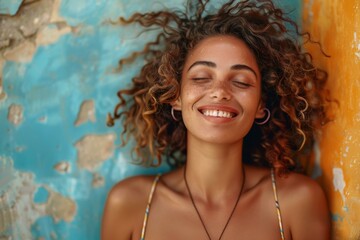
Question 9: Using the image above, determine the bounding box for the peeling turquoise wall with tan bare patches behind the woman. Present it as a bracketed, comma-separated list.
[0, 0, 301, 240]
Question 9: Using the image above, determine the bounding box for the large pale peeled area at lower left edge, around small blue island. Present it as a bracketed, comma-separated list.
[0, 156, 76, 239]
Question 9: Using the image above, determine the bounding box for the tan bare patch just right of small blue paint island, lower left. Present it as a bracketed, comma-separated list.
[45, 190, 76, 222]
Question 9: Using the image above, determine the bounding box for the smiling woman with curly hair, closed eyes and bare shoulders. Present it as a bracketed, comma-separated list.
[102, 0, 330, 240]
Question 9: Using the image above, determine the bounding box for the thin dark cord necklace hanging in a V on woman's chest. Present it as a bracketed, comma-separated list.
[184, 165, 245, 240]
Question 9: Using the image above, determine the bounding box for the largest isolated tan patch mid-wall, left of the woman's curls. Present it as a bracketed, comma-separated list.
[75, 134, 116, 171]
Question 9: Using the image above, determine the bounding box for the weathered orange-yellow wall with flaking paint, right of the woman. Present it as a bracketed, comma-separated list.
[303, 0, 360, 240]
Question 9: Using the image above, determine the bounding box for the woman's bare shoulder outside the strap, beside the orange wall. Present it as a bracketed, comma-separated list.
[276, 173, 330, 239]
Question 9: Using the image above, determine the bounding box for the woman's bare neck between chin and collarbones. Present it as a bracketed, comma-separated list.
[185, 135, 243, 202]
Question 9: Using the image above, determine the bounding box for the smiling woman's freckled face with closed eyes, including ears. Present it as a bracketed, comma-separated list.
[173, 35, 264, 144]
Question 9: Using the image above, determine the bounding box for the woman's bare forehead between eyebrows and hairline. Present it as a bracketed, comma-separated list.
[184, 35, 259, 71]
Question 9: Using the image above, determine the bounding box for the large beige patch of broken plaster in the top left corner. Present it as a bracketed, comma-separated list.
[0, 0, 77, 62]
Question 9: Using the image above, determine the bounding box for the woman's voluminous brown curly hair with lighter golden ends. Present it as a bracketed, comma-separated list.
[108, 0, 328, 172]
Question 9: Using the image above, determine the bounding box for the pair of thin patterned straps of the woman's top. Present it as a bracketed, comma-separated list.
[140, 168, 285, 240]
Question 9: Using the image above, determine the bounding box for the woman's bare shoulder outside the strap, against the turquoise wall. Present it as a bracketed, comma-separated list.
[101, 176, 158, 240]
